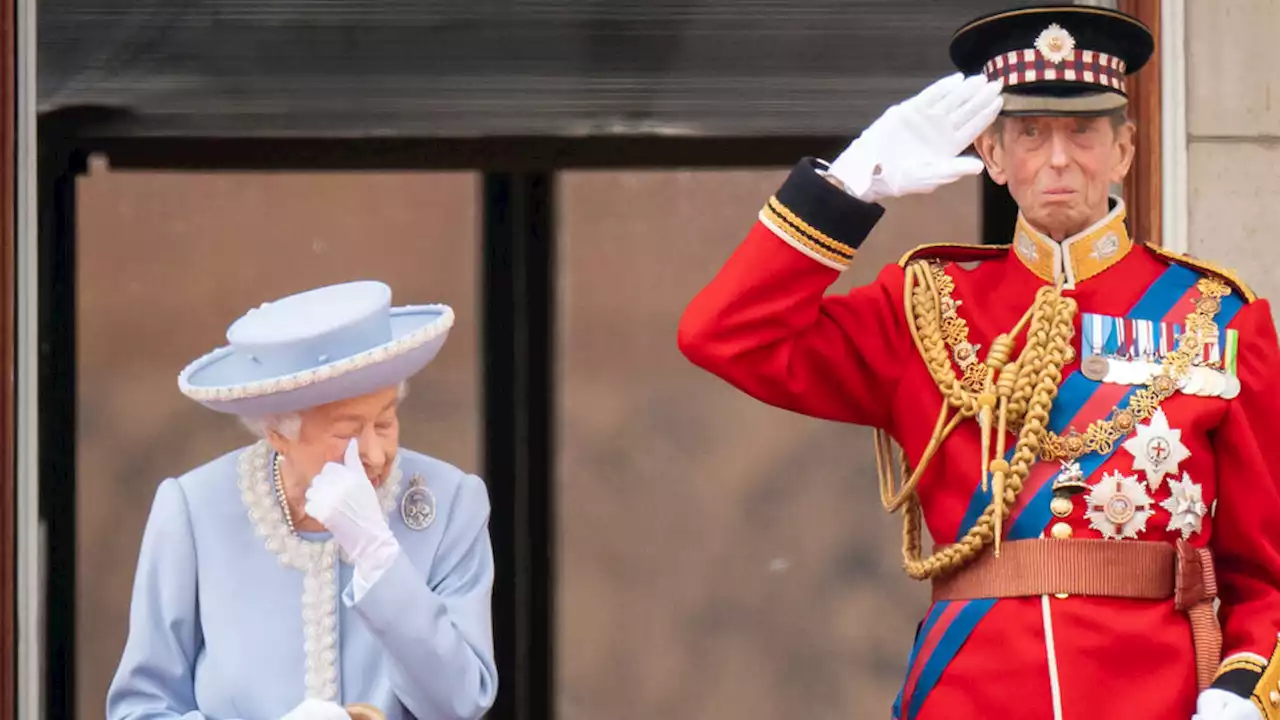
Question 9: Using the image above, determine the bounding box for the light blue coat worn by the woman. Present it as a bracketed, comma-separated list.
[106, 443, 497, 720]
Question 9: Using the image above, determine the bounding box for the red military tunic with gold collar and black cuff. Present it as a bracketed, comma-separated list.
[680, 160, 1280, 720]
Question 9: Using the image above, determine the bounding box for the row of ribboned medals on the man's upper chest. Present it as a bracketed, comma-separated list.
[1080, 313, 1240, 400]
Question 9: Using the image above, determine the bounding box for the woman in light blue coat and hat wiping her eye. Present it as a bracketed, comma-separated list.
[106, 282, 497, 720]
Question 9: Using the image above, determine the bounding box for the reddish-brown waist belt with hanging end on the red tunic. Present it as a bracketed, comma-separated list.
[933, 539, 1222, 689]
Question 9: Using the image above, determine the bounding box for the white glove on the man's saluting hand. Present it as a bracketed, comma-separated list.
[831, 73, 1005, 202]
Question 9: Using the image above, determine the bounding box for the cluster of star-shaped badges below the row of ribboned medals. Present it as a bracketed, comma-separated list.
[1050, 410, 1208, 539]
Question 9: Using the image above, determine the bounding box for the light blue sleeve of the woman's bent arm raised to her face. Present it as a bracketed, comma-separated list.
[343, 475, 498, 720]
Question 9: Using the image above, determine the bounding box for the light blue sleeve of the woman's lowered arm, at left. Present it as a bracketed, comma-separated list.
[106, 478, 227, 720]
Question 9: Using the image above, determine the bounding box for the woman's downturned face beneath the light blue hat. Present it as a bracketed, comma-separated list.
[271, 386, 399, 487]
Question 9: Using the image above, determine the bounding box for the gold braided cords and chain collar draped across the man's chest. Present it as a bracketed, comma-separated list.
[876, 260, 1230, 580]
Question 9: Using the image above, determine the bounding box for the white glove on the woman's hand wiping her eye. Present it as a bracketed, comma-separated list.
[306, 439, 399, 585]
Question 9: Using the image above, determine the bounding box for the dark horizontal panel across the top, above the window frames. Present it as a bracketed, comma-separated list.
[38, 0, 1039, 138]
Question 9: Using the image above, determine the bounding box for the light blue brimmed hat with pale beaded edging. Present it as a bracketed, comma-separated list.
[178, 281, 453, 416]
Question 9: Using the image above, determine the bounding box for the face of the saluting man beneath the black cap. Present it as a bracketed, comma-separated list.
[977, 115, 1134, 241]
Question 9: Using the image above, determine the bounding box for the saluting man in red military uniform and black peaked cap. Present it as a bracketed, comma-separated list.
[680, 6, 1280, 720]
